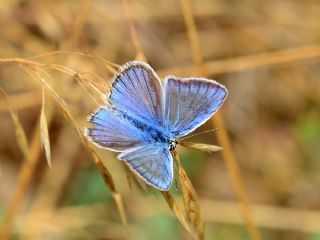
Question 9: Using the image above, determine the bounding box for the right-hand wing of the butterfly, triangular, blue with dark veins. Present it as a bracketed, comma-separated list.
[164, 76, 228, 138]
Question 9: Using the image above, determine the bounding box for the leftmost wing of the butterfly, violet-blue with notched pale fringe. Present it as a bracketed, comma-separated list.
[85, 107, 148, 152]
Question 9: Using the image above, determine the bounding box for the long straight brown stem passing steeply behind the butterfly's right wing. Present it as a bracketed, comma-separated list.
[180, 0, 262, 240]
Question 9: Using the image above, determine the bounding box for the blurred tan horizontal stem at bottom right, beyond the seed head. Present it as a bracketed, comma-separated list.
[200, 199, 320, 234]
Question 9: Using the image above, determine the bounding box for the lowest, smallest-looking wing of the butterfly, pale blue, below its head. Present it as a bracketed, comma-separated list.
[118, 144, 173, 191]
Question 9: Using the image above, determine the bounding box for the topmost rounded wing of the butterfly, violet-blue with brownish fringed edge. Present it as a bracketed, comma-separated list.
[109, 61, 163, 126]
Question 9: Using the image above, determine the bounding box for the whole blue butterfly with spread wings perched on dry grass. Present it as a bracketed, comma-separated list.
[85, 61, 228, 191]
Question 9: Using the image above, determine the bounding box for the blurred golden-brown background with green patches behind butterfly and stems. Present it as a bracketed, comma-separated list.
[0, 0, 320, 240]
